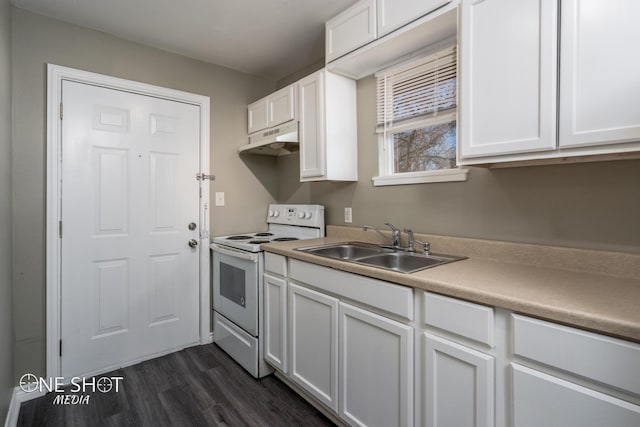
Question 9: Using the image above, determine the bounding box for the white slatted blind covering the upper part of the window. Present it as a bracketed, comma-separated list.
[376, 46, 457, 132]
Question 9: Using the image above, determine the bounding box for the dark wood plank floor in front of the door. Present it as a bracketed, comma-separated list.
[18, 344, 333, 427]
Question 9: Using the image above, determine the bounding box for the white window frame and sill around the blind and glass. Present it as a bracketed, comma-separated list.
[372, 40, 469, 187]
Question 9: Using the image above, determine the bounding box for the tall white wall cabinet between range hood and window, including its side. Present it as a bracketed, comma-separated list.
[298, 69, 358, 181]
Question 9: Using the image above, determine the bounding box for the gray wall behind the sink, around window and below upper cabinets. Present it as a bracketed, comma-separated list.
[278, 77, 640, 253]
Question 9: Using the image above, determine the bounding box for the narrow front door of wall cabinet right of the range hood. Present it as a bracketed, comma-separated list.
[298, 71, 326, 181]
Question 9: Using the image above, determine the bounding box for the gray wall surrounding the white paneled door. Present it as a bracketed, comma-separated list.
[10, 8, 277, 377]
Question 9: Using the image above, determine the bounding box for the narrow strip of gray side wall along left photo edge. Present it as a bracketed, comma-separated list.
[0, 0, 14, 424]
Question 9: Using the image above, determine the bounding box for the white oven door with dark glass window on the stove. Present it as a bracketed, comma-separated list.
[211, 244, 262, 336]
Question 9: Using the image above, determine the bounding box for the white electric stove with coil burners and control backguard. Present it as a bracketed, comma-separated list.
[211, 205, 325, 378]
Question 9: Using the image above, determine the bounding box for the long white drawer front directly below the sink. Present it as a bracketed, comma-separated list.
[289, 259, 413, 320]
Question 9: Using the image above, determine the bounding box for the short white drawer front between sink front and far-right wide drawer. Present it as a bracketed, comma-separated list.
[424, 292, 494, 347]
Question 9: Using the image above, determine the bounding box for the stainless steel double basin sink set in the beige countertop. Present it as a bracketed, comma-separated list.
[297, 242, 466, 273]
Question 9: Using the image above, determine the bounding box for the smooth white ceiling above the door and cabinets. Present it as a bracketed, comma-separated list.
[12, 0, 356, 80]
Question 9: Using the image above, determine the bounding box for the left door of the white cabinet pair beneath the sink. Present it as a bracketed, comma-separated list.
[289, 283, 338, 412]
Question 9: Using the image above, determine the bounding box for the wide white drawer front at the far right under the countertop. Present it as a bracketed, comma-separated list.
[512, 314, 640, 395]
